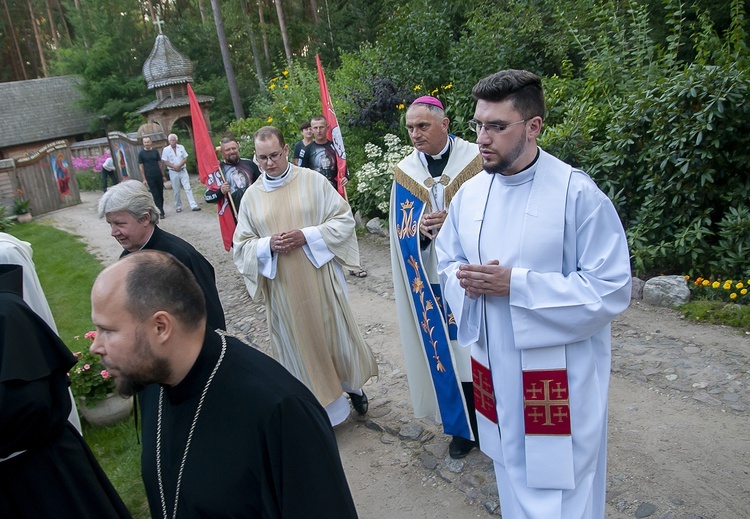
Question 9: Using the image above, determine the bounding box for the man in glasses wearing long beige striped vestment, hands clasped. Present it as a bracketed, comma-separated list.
[233, 126, 378, 425]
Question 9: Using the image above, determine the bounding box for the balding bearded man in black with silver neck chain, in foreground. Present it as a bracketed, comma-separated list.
[91, 251, 357, 519]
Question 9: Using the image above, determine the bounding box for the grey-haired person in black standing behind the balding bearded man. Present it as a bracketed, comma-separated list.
[99, 182, 226, 330]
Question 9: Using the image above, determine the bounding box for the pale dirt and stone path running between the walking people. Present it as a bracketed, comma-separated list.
[41, 187, 750, 519]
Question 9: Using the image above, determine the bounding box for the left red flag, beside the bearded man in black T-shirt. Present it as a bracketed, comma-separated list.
[188, 83, 237, 250]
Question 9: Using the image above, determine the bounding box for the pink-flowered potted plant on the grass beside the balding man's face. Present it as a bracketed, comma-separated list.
[69, 331, 133, 425]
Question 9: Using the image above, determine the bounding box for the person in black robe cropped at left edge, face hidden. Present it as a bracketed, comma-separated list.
[0, 265, 130, 519]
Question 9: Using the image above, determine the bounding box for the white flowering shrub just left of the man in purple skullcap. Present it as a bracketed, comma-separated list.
[355, 133, 414, 217]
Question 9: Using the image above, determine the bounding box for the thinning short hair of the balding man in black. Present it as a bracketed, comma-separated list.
[125, 250, 207, 330]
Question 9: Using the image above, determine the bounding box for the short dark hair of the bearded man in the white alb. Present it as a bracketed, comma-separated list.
[471, 69, 544, 119]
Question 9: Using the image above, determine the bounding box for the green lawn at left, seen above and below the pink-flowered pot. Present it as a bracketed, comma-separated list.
[9, 222, 149, 518]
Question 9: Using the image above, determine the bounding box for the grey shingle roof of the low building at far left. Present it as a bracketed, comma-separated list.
[0, 76, 96, 147]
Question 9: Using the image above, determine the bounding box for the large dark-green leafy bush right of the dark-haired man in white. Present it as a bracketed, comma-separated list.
[542, 1, 750, 274]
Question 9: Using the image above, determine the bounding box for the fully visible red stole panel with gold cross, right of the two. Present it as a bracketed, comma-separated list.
[523, 369, 570, 436]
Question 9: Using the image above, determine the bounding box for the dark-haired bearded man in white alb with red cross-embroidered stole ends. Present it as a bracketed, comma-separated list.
[436, 70, 631, 519]
